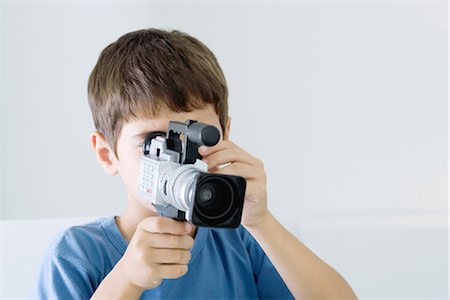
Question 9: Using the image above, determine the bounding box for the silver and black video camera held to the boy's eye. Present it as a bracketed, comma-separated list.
[138, 120, 246, 227]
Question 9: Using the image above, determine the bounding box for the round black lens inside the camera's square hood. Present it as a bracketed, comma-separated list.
[196, 177, 234, 220]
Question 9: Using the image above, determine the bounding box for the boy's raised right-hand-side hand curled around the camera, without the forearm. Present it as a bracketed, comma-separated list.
[199, 141, 268, 228]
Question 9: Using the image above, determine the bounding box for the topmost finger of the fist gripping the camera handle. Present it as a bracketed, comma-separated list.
[138, 216, 193, 234]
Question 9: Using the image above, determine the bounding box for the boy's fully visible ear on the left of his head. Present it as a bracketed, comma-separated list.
[91, 131, 117, 176]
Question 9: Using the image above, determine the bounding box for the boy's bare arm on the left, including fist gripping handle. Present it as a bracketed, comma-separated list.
[91, 216, 194, 299]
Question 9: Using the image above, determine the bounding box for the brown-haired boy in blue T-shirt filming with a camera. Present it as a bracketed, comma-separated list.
[37, 29, 355, 299]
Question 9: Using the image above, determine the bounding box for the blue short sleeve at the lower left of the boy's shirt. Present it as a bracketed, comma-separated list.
[33, 255, 94, 300]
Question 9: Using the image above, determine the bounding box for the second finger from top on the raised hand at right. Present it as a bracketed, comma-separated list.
[204, 148, 259, 169]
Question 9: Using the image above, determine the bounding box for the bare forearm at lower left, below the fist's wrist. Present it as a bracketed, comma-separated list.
[91, 261, 143, 300]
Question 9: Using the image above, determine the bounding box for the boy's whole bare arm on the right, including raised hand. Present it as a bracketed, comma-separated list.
[199, 141, 357, 300]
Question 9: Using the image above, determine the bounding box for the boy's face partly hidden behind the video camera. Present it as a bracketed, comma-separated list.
[92, 104, 229, 212]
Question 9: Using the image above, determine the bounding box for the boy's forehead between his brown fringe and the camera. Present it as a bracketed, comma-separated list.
[122, 104, 222, 137]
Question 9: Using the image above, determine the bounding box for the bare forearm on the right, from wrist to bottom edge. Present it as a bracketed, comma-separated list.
[247, 212, 357, 300]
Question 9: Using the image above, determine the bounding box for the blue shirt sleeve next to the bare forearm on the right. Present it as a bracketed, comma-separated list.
[242, 227, 294, 299]
